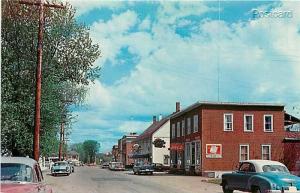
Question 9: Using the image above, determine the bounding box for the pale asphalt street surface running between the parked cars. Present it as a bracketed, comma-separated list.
[44, 166, 243, 193]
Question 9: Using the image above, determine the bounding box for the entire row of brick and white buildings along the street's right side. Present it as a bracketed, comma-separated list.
[112, 102, 300, 177]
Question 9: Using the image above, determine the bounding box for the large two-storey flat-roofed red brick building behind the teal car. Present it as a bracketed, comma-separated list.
[170, 102, 285, 177]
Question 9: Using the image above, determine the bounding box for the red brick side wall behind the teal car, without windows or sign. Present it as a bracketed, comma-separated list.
[202, 108, 285, 171]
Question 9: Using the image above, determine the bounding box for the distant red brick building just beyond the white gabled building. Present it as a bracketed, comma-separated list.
[118, 133, 138, 166]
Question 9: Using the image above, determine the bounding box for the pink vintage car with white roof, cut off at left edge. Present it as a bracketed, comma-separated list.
[1, 157, 52, 193]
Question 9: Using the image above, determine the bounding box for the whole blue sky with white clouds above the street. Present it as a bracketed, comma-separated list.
[66, 0, 300, 151]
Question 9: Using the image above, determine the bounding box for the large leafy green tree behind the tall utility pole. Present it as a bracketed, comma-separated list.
[1, 0, 100, 156]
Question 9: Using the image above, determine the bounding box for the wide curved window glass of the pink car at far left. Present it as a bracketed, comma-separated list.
[1, 163, 32, 182]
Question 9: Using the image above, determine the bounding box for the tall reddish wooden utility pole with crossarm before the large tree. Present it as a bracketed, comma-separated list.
[19, 0, 64, 161]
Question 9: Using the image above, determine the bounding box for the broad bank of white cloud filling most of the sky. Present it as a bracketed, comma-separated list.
[72, 2, 300, 150]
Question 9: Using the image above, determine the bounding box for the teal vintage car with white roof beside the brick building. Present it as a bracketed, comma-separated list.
[221, 160, 300, 193]
